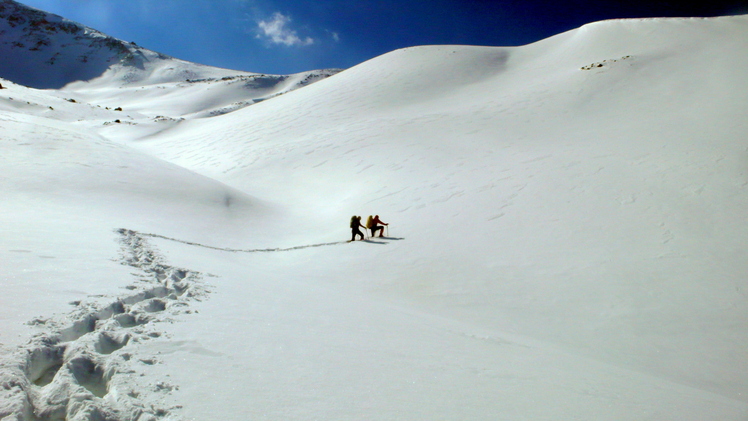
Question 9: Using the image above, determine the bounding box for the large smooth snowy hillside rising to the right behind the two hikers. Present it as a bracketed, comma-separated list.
[125, 13, 748, 404]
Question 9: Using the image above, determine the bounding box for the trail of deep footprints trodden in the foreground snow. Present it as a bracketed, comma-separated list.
[0, 229, 209, 421]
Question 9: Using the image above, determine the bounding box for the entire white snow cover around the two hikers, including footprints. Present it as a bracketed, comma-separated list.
[0, 7, 748, 421]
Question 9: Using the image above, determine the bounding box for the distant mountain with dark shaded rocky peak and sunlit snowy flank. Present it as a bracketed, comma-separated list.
[0, 0, 339, 121]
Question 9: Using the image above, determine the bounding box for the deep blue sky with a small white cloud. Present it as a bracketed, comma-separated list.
[20, 0, 748, 74]
